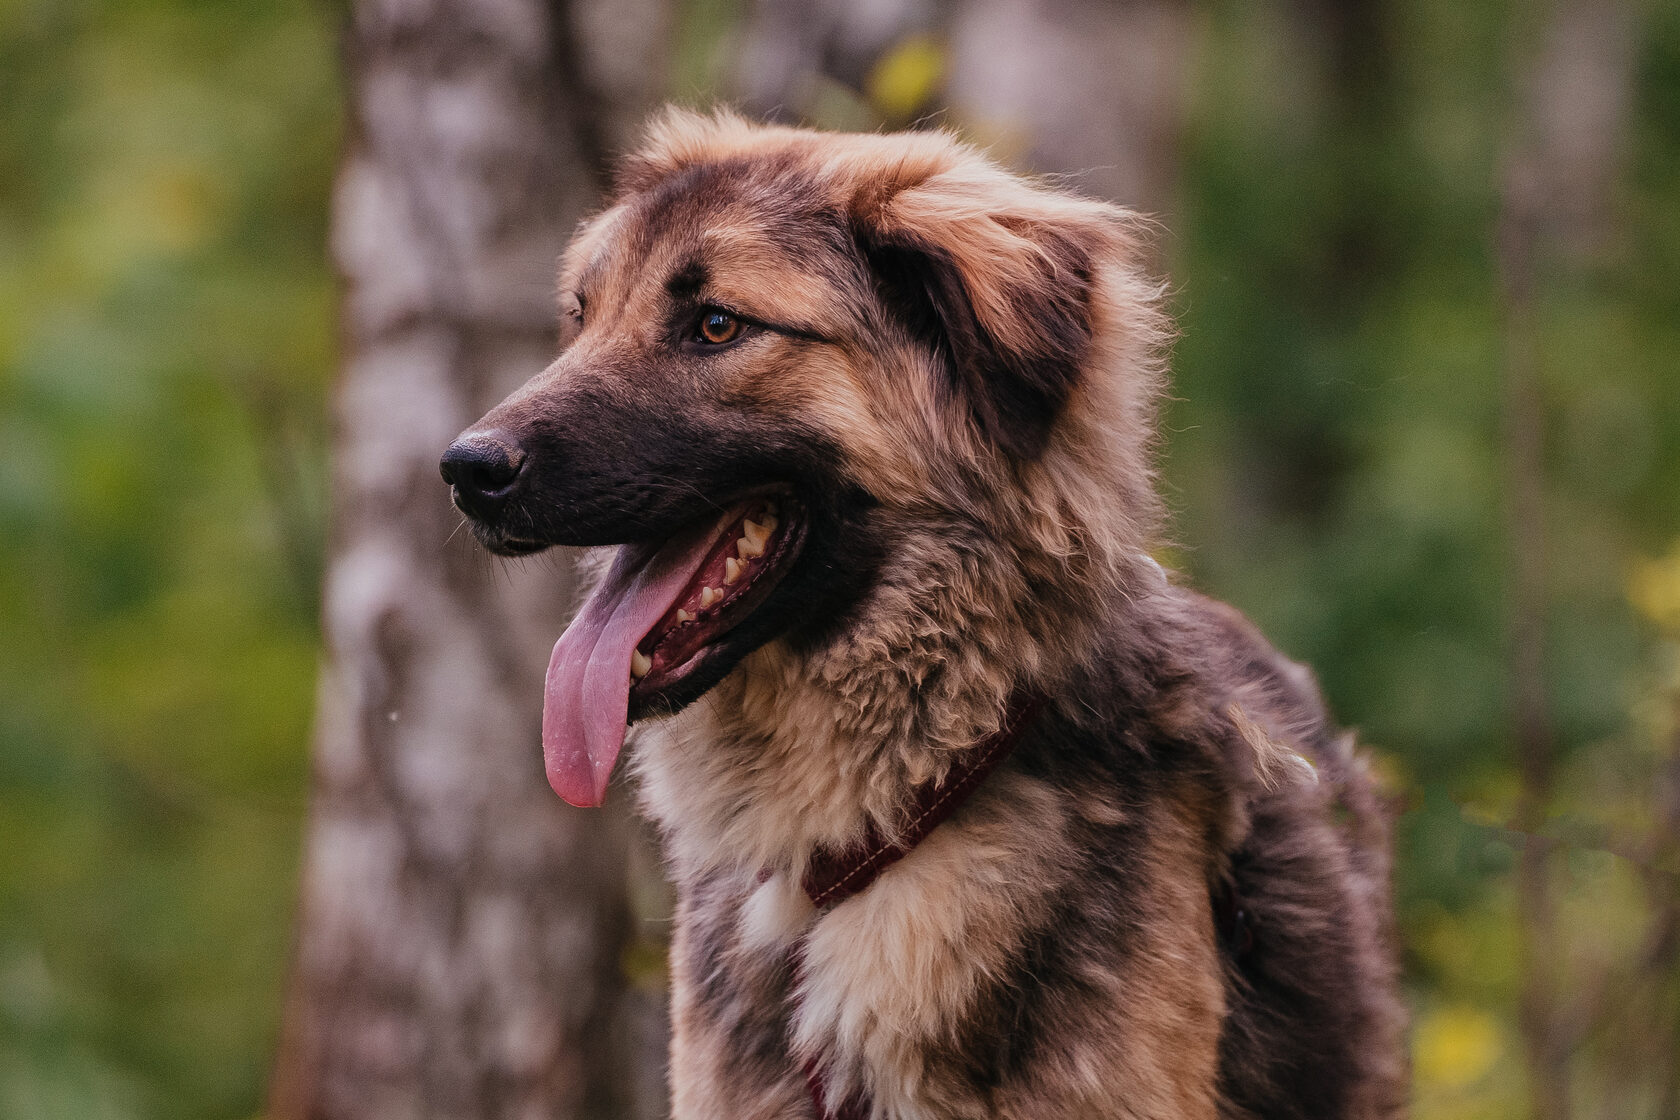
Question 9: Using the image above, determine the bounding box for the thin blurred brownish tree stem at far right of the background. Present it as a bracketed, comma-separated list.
[1497, 0, 1632, 1120]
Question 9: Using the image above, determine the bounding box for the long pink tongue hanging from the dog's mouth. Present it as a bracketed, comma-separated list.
[543, 524, 717, 808]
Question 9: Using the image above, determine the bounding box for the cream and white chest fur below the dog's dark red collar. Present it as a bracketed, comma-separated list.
[689, 779, 1055, 1120]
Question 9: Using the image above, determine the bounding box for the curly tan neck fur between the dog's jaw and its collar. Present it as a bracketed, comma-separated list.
[633, 503, 1161, 882]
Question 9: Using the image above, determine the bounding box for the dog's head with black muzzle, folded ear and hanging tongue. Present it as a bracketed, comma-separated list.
[442, 114, 1162, 804]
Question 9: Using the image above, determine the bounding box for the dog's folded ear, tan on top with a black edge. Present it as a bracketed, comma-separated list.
[852, 160, 1121, 458]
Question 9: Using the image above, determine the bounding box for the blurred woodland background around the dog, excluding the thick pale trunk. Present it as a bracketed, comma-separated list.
[0, 0, 1680, 1120]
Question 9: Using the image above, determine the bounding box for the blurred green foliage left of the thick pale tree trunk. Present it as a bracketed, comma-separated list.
[0, 0, 338, 1120]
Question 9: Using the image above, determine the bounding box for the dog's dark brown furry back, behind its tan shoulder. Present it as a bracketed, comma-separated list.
[1105, 588, 1404, 1117]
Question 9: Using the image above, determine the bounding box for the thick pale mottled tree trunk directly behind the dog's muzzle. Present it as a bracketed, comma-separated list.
[270, 0, 664, 1120]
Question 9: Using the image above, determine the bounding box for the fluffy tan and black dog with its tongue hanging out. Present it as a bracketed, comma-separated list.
[442, 111, 1406, 1120]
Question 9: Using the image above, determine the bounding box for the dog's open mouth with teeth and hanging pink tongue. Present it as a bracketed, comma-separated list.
[543, 492, 806, 806]
